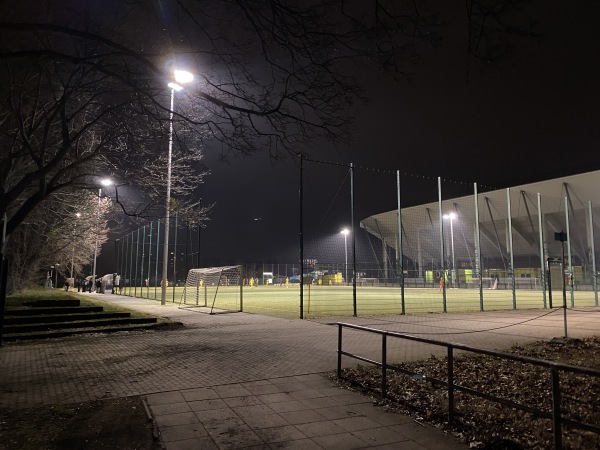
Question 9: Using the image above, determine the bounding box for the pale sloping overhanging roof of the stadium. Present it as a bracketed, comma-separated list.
[360, 171, 600, 267]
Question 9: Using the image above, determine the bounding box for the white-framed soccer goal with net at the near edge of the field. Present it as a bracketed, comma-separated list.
[179, 266, 242, 314]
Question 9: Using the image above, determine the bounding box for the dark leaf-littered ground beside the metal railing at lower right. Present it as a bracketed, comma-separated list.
[332, 337, 600, 450]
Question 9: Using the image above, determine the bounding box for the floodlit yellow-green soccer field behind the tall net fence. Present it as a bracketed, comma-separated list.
[124, 284, 596, 318]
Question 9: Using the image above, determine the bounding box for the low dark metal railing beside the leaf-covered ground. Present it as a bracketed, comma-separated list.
[337, 323, 600, 450]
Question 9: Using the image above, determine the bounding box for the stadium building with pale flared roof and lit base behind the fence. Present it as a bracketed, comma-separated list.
[360, 171, 600, 304]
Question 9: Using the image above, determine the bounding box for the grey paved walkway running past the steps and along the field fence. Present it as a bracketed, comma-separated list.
[0, 294, 600, 450]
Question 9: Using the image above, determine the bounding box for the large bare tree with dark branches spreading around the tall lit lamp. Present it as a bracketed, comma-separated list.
[0, 0, 536, 260]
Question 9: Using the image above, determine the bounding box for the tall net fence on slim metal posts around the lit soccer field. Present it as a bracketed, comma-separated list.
[115, 159, 600, 318]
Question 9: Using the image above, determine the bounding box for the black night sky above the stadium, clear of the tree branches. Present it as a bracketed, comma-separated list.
[100, 1, 600, 274]
